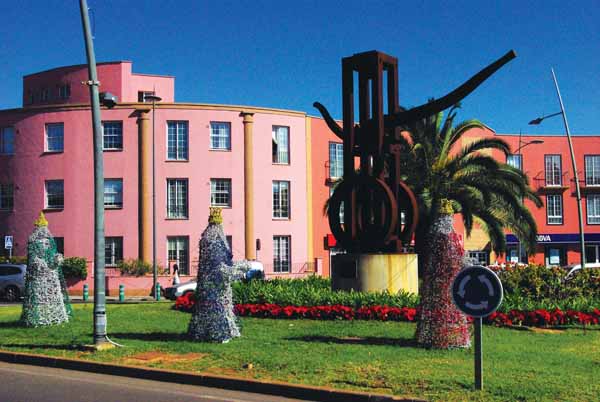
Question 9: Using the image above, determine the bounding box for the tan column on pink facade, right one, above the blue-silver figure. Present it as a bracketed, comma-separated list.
[240, 112, 256, 260]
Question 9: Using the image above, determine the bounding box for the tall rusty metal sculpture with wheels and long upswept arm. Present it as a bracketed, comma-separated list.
[314, 50, 516, 253]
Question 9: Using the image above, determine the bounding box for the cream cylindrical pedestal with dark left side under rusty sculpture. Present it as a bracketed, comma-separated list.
[331, 254, 419, 294]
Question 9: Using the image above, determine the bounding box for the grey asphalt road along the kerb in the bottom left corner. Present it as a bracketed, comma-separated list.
[0, 362, 310, 402]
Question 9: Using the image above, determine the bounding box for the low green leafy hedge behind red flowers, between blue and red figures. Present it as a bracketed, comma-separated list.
[233, 276, 418, 307]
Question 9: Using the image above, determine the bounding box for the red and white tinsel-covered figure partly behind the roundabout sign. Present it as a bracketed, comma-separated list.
[415, 214, 471, 349]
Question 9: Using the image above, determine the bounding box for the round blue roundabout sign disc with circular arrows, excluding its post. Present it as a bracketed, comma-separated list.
[452, 265, 503, 317]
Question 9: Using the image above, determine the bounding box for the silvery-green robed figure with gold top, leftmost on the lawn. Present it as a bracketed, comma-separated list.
[21, 213, 71, 327]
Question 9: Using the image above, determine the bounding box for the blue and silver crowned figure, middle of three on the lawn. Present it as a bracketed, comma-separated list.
[188, 208, 250, 342]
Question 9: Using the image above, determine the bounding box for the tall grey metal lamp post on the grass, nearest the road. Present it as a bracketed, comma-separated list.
[79, 0, 109, 347]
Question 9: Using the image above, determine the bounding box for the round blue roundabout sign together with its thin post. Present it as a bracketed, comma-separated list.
[452, 265, 503, 390]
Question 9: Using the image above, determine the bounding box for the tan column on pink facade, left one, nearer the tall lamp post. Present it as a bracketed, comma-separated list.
[137, 109, 152, 262]
